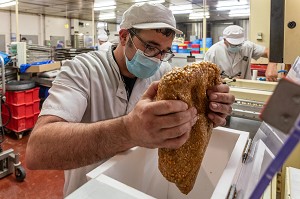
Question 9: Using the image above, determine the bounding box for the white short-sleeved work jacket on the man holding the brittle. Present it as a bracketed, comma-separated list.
[40, 48, 171, 196]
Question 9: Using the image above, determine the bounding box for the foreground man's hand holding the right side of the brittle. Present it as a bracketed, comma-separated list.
[207, 84, 235, 127]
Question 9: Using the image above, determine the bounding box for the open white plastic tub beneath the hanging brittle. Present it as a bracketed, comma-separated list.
[70, 127, 249, 199]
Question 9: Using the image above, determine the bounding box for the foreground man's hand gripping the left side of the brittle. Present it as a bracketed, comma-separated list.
[123, 82, 198, 148]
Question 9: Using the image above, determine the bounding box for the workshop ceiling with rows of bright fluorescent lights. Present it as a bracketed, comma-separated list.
[0, 0, 249, 23]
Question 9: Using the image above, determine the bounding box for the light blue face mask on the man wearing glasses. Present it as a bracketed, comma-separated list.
[125, 49, 162, 79]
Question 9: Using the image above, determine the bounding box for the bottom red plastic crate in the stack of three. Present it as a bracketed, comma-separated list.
[2, 114, 39, 132]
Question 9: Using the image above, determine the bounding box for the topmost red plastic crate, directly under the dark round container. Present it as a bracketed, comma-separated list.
[5, 87, 40, 104]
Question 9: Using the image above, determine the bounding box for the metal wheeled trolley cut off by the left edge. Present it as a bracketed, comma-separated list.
[0, 56, 26, 181]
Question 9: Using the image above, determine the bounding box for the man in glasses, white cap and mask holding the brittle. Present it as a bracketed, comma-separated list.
[26, 3, 234, 196]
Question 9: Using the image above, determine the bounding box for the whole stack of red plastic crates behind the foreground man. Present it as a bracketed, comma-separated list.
[2, 87, 40, 132]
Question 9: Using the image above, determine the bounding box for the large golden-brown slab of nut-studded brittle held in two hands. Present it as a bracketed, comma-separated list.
[156, 62, 221, 194]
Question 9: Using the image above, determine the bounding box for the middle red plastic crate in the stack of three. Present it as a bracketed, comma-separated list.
[2, 100, 40, 118]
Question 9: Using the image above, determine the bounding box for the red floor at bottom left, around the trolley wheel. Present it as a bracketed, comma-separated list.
[0, 132, 64, 199]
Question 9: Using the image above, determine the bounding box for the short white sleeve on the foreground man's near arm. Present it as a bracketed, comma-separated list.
[40, 56, 90, 122]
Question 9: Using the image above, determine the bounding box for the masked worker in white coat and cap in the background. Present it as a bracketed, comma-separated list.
[204, 25, 277, 81]
